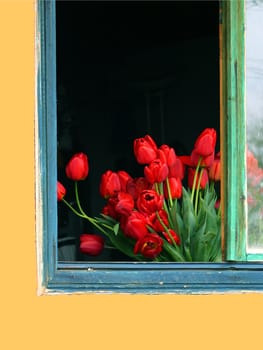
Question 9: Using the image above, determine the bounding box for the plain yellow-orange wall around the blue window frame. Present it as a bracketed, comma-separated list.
[0, 0, 263, 350]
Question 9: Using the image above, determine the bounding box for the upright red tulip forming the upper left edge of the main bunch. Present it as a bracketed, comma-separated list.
[100, 170, 121, 198]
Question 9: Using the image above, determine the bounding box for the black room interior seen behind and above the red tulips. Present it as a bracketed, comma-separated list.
[56, 1, 219, 260]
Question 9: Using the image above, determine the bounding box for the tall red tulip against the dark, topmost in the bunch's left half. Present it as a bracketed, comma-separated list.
[133, 135, 158, 164]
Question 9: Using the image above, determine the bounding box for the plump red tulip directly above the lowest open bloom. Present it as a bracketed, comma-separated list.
[121, 211, 149, 240]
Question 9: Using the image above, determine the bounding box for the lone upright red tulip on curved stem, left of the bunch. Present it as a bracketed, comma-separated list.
[66, 153, 89, 181]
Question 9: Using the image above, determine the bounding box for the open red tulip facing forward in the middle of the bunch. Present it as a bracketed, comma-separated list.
[136, 190, 164, 215]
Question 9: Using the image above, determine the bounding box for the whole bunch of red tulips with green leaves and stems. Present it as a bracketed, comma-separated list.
[57, 128, 221, 262]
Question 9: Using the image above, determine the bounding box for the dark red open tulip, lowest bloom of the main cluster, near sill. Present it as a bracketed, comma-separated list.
[134, 233, 163, 259]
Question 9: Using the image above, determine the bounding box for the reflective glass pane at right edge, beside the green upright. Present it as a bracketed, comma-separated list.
[246, 0, 263, 251]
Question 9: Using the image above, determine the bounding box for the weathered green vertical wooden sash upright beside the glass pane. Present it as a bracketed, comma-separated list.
[221, 0, 247, 261]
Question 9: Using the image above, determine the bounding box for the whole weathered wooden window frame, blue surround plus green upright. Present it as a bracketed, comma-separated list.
[36, 1, 263, 293]
